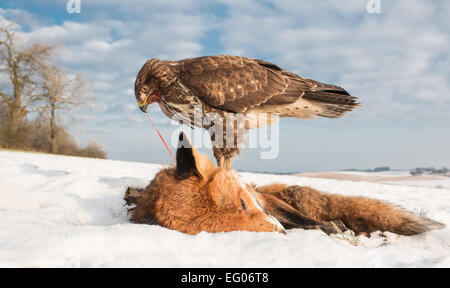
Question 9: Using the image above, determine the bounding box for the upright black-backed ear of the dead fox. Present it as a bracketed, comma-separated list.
[176, 132, 217, 181]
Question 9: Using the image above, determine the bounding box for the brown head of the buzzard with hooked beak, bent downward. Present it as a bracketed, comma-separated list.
[134, 60, 161, 112]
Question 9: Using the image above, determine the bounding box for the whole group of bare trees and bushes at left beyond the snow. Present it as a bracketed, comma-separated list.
[0, 23, 106, 158]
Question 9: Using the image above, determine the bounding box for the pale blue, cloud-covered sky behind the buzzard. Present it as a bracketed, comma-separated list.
[0, 0, 450, 172]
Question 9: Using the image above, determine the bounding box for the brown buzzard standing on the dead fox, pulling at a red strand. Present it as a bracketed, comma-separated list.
[134, 55, 360, 168]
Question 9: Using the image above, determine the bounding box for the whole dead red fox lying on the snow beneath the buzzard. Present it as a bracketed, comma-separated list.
[125, 133, 445, 235]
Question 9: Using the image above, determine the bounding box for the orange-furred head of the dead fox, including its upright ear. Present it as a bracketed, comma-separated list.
[133, 133, 284, 234]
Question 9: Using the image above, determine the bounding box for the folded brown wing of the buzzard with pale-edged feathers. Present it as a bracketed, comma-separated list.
[179, 55, 317, 112]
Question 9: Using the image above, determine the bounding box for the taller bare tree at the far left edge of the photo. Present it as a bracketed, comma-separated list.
[0, 24, 54, 141]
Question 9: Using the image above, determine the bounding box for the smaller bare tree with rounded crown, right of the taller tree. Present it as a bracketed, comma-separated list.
[41, 66, 88, 153]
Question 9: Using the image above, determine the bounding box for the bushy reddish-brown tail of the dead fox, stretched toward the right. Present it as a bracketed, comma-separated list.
[257, 185, 445, 235]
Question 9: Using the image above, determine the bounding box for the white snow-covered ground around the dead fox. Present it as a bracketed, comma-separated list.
[0, 151, 450, 267]
